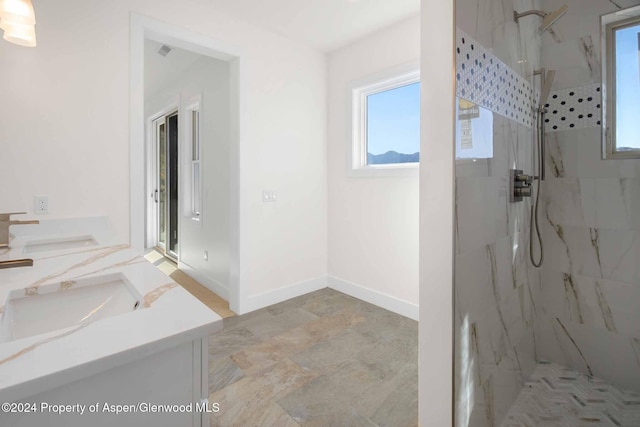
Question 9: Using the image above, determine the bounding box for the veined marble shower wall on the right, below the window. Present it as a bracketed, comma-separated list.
[536, 0, 640, 391]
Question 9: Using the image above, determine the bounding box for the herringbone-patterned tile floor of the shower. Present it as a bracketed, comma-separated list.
[501, 362, 640, 427]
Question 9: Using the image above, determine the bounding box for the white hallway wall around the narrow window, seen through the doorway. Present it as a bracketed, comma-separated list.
[145, 52, 230, 298]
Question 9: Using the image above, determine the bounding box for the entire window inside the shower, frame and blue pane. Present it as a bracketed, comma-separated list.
[601, 6, 640, 158]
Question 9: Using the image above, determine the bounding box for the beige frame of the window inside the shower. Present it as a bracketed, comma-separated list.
[600, 6, 640, 160]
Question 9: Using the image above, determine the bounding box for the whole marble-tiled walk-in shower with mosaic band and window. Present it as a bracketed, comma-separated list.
[451, 0, 640, 427]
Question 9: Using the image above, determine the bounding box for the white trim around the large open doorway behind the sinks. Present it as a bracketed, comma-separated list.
[129, 13, 249, 314]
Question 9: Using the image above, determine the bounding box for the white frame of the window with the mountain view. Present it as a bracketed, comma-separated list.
[347, 61, 422, 176]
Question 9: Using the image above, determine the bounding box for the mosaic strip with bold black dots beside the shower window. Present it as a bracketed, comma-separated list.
[545, 84, 602, 132]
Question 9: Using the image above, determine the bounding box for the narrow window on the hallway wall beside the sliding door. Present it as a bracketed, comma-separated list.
[182, 96, 202, 221]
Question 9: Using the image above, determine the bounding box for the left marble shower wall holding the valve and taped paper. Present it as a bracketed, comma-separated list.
[455, 0, 541, 427]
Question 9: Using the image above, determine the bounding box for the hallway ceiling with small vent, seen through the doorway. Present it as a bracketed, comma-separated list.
[144, 39, 202, 95]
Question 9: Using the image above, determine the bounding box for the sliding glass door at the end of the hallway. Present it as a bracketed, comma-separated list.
[152, 110, 180, 262]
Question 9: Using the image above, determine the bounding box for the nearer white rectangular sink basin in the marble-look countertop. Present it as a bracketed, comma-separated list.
[0, 273, 142, 342]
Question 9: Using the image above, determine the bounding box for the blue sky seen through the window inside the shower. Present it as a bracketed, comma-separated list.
[615, 24, 640, 151]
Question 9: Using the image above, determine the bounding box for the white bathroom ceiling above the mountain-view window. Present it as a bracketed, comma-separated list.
[210, 0, 420, 52]
